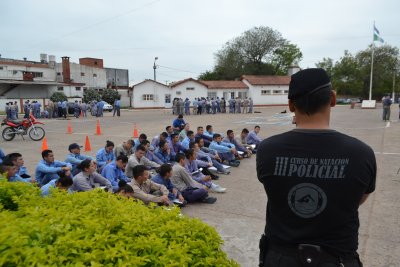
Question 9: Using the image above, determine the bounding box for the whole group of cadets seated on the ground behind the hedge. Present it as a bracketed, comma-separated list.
[0, 119, 261, 206]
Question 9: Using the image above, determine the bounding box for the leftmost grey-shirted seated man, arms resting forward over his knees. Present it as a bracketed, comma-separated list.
[70, 159, 112, 192]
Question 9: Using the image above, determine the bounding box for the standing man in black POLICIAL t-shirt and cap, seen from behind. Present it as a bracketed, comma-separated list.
[257, 69, 376, 267]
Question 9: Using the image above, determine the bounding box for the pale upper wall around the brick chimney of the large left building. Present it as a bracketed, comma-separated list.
[56, 63, 107, 89]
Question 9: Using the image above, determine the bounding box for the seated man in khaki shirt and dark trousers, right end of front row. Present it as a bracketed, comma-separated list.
[171, 154, 217, 204]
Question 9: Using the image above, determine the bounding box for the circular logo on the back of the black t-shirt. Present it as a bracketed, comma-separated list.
[288, 183, 327, 218]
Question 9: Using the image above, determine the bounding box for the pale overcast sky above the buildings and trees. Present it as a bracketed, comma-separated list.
[0, 0, 400, 85]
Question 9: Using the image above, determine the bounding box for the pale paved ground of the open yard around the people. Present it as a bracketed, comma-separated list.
[0, 106, 400, 267]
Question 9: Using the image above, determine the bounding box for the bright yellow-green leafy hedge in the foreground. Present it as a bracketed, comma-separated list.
[0, 181, 238, 267]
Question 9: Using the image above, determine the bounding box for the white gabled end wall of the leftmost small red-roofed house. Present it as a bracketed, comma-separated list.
[132, 81, 174, 108]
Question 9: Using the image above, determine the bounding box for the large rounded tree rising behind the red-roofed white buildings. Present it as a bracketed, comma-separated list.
[199, 26, 302, 80]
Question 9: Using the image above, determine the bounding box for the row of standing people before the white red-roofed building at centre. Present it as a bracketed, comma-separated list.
[172, 97, 254, 115]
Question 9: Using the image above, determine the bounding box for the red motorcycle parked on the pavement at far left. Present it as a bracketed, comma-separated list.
[1, 114, 46, 141]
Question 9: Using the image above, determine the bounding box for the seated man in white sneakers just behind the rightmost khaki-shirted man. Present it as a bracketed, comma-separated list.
[185, 149, 226, 193]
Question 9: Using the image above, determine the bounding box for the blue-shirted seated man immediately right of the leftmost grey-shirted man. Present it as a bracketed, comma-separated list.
[101, 155, 130, 192]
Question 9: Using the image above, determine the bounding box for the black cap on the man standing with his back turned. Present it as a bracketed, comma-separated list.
[288, 68, 332, 100]
